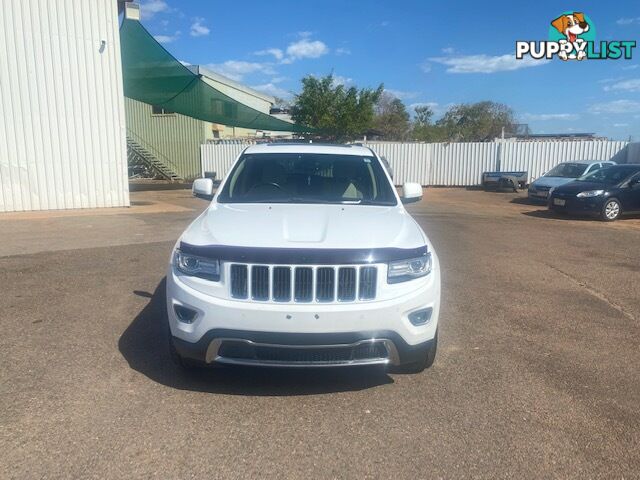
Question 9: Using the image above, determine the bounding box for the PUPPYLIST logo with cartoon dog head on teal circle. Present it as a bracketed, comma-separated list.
[516, 12, 636, 61]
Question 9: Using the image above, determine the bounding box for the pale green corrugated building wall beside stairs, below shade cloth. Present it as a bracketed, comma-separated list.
[125, 98, 205, 178]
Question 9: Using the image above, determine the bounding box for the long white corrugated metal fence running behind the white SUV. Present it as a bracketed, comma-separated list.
[201, 141, 633, 186]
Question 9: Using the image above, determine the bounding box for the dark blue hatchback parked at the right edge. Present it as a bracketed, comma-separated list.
[549, 165, 640, 222]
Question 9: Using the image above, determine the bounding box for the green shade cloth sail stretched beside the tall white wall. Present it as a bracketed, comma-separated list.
[120, 18, 312, 132]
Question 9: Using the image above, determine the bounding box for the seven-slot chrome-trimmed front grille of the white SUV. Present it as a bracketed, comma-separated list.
[229, 264, 378, 303]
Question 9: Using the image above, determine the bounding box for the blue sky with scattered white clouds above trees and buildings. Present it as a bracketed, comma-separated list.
[141, 0, 640, 140]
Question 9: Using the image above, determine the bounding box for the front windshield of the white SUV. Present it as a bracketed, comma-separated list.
[218, 153, 396, 205]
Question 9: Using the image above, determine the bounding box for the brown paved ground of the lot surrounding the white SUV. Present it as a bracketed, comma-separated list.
[0, 189, 640, 478]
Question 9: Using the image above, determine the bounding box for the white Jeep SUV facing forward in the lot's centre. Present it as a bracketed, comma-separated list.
[167, 144, 440, 372]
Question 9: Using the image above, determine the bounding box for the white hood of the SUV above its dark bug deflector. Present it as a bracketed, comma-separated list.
[182, 203, 426, 248]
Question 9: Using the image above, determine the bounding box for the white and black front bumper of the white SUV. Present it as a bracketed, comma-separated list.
[167, 258, 440, 366]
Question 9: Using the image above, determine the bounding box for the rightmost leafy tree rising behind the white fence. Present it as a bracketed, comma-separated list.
[436, 101, 515, 142]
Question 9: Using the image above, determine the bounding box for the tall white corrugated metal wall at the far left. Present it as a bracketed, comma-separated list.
[0, 0, 129, 211]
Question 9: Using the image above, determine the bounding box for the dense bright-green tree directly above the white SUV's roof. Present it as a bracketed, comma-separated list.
[291, 74, 383, 141]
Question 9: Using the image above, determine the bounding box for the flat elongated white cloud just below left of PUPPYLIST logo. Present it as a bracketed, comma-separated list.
[429, 54, 550, 73]
